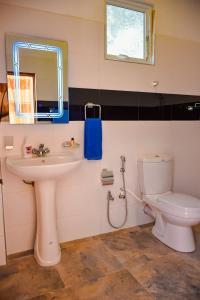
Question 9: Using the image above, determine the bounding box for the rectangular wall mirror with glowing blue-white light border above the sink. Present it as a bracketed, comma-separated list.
[6, 34, 69, 124]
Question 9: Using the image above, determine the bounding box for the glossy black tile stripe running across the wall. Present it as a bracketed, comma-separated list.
[69, 88, 200, 121]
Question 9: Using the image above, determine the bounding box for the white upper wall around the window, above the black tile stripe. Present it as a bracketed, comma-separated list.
[0, 0, 200, 94]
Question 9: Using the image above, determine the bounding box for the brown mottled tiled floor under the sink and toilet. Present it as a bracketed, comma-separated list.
[0, 227, 200, 300]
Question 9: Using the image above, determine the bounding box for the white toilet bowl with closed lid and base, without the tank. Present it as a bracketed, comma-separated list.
[143, 192, 200, 252]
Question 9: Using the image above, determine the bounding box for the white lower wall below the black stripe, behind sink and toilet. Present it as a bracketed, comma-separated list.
[1, 121, 200, 254]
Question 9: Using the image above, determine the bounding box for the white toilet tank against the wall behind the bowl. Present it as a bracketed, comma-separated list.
[138, 155, 173, 195]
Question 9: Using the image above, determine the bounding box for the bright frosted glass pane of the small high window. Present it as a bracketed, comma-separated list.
[107, 5, 145, 59]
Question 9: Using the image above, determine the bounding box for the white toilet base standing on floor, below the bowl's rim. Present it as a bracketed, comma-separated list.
[152, 220, 195, 252]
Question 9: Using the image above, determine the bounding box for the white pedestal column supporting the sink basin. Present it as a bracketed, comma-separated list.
[34, 179, 61, 266]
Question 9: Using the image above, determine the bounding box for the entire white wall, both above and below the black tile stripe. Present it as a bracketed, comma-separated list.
[0, 0, 200, 254]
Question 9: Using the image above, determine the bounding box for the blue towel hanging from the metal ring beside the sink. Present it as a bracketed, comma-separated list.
[84, 118, 102, 160]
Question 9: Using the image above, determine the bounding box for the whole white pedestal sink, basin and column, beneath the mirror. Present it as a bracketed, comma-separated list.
[6, 155, 81, 266]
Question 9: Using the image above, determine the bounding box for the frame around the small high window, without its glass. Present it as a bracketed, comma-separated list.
[104, 0, 155, 65]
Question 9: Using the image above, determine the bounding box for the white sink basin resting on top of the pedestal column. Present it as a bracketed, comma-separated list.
[6, 155, 81, 181]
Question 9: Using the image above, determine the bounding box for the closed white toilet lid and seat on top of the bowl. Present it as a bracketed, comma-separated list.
[157, 193, 200, 218]
